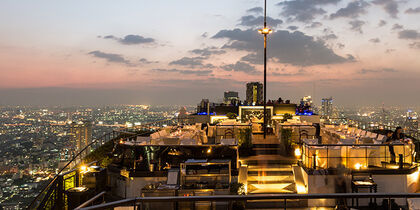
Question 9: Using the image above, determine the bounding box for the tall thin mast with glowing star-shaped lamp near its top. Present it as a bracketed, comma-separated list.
[258, 0, 273, 139]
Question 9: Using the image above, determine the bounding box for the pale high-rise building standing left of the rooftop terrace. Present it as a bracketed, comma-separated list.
[70, 121, 92, 150]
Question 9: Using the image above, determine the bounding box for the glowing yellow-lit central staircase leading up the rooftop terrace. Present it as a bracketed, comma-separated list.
[242, 136, 305, 209]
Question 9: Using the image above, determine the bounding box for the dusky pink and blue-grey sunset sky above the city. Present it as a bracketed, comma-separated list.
[0, 0, 420, 105]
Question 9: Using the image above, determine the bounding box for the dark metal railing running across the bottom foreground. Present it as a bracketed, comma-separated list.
[80, 193, 420, 210]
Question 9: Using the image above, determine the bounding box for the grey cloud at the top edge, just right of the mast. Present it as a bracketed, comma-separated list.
[277, 0, 341, 22]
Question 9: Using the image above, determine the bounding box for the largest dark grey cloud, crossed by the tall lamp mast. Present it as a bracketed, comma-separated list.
[212, 29, 348, 66]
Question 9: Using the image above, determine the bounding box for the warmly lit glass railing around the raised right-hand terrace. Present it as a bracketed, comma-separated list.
[302, 143, 415, 170]
